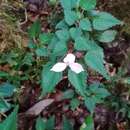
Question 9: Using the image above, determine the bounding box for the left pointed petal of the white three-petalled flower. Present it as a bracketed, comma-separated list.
[51, 62, 67, 72]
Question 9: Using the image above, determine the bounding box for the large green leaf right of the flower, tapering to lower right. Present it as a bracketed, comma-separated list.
[85, 50, 110, 79]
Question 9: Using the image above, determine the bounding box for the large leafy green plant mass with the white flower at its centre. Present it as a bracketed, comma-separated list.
[25, 0, 122, 130]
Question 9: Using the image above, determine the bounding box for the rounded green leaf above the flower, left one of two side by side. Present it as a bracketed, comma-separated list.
[56, 29, 70, 41]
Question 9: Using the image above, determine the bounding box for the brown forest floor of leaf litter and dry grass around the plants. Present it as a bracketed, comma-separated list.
[0, 0, 130, 130]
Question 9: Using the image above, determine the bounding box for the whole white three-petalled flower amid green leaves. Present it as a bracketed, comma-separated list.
[51, 53, 84, 74]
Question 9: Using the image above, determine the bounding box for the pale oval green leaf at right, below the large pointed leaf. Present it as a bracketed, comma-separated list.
[97, 30, 117, 43]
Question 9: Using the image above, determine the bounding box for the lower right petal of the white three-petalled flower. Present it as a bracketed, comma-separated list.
[69, 63, 84, 74]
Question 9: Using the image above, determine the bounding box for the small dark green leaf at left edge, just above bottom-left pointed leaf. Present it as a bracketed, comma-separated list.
[0, 98, 11, 113]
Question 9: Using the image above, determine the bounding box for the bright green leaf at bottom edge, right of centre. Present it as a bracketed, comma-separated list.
[80, 115, 94, 130]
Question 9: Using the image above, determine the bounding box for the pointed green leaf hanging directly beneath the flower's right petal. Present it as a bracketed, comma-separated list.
[68, 70, 87, 96]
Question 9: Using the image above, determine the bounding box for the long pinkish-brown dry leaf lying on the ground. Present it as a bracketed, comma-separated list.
[25, 99, 54, 116]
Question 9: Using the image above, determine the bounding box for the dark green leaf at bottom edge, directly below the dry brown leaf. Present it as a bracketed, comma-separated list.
[36, 117, 46, 130]
